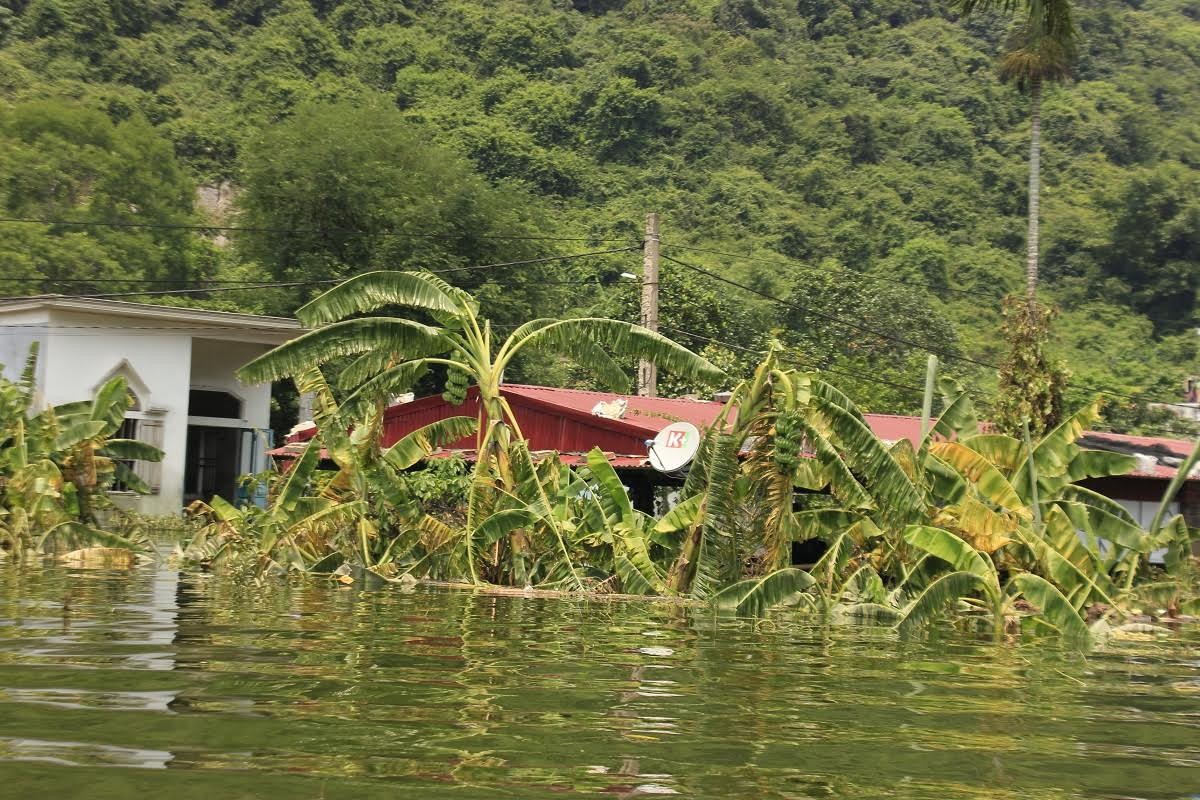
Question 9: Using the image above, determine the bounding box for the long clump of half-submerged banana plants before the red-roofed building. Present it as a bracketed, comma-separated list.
[175, 278, 1200, 639]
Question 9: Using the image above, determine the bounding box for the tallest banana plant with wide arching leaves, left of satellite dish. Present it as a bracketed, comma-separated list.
[239, 271, 724, 588]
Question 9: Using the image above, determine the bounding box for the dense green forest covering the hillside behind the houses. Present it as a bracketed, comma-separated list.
[0, 0, 1200, 431]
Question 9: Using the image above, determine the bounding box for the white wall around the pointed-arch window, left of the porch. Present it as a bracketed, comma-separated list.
[42, 311, 192, 515]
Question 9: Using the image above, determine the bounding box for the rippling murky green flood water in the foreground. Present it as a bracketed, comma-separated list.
[0, 556, 1200, 800]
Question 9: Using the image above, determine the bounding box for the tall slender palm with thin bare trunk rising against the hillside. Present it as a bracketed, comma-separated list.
[953, 0, 1079, 320]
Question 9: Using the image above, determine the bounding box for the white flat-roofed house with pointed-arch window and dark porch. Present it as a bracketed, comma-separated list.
[0, 295, 302, 513]
